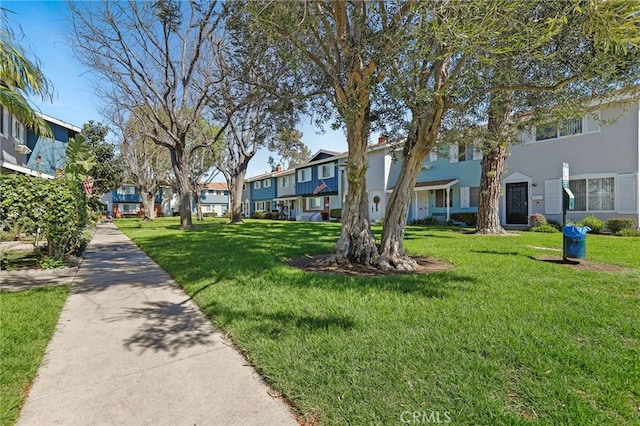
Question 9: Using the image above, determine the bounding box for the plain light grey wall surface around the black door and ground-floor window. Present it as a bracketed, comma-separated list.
[508, 103, 640, 223]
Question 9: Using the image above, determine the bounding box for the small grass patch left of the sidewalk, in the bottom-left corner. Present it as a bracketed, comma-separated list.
[0, 286, 70, 426]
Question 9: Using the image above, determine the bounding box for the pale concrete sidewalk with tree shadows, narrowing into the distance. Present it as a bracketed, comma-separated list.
[18, 223, 297, 426]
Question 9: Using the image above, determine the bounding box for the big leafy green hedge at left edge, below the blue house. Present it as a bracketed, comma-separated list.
[0, 174, 88, 257]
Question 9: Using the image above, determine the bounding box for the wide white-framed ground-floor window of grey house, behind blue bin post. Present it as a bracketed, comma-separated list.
[569, 177, 615, 211]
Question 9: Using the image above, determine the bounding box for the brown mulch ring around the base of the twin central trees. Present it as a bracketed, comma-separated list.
[285, 254, 453, 277]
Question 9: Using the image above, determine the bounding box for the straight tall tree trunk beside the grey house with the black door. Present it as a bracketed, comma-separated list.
[476, 92, 512, 234]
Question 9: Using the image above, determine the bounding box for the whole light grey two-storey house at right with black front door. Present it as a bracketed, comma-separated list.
[508, 100, 640, 225]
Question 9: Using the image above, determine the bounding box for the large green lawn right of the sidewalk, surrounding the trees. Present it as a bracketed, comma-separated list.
[117, 218, 640, 425]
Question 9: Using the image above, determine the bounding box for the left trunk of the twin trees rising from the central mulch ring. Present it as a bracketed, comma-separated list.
[331, 115, 379, 267]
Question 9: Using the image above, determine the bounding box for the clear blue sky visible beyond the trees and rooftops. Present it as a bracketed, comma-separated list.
[1, 0, 356, 181]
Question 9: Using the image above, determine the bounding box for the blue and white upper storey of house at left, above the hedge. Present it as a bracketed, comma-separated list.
[0, 107, 81, 179]
